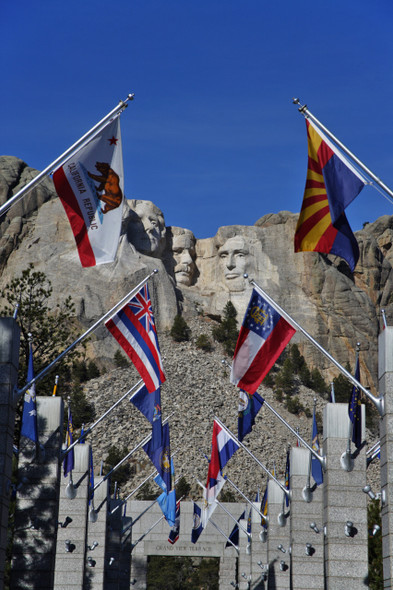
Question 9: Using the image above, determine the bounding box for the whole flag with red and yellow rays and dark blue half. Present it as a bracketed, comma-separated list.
[295, 120, 365, 272]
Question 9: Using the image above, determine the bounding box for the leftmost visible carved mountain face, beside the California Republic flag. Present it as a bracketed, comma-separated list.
[127, 199, 166, 258]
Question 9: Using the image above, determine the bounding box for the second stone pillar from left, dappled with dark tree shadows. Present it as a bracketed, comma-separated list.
[11, 396, 63, 590]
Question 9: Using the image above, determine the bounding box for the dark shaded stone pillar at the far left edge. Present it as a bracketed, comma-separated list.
[0, 318, 20, 588]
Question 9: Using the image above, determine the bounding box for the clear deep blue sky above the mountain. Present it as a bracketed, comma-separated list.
[0, 0, 393, 238]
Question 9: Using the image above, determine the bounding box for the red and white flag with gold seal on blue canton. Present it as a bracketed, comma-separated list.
[231, 289, 296, 395]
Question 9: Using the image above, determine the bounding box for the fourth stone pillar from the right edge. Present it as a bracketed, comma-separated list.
[267, 480, 291, 590]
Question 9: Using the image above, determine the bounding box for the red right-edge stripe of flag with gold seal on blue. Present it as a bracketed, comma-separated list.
[237, 317, 296, 395]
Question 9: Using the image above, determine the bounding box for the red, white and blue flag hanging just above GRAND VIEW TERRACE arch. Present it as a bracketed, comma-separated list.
[202, 420, 239, 527]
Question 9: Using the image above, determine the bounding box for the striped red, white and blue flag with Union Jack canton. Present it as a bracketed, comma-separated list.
[105, 285, 165, 393]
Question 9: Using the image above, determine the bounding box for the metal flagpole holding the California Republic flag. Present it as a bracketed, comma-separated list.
[0, 94, 134, 218]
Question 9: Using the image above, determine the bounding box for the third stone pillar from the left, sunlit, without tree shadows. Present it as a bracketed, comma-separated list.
[53, 443, 90, 590]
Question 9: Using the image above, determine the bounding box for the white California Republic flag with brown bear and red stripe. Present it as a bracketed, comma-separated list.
[53, 117, 124, 266]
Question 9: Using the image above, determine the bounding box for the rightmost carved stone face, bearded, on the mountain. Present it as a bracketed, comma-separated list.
[218, 236, 251, 291]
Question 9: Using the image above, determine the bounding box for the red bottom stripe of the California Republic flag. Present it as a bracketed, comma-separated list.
[53, 167, 96, 267]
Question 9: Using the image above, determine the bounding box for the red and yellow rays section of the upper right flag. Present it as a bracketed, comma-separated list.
[295, 121, 338, 254]
